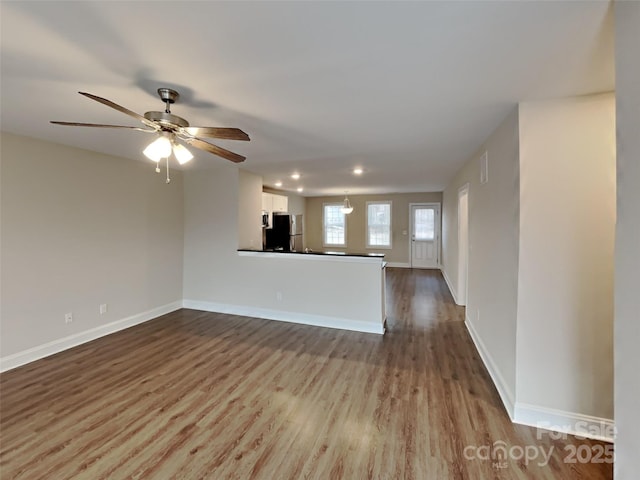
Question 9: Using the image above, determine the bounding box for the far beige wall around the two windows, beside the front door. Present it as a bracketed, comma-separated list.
[305, 192, 442, 266]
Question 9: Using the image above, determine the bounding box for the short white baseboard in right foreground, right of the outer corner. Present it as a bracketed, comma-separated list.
[513, 402, 615, 442]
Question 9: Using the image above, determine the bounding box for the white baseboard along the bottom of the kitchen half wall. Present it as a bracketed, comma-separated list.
[183, 300, 384, 335]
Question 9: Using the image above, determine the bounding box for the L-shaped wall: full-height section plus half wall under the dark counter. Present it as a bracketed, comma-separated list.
[184, 166, 382, 333]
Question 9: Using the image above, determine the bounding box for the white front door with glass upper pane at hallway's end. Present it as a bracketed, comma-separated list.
[410, 203, 440, 268]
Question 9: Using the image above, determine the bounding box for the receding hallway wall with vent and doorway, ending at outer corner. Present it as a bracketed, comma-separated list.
[442, 108, 519, 415]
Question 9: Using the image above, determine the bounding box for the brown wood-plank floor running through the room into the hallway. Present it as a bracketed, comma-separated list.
[0, 269, 612, 480]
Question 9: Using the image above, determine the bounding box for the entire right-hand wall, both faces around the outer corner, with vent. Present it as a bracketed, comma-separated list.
[443, 94, 615, 436]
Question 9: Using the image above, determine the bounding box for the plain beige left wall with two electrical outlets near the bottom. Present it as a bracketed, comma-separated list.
[0, 133, 183, 368]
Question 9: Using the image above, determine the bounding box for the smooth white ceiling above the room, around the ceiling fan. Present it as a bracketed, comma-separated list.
[0, 1, 614, 195]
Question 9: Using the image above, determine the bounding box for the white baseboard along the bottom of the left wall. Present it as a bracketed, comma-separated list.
[0, 300, 182, 372]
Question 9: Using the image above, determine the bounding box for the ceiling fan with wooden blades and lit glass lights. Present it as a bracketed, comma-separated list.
[51, 88, 249, 169]
